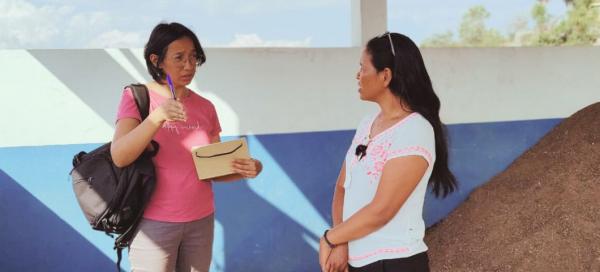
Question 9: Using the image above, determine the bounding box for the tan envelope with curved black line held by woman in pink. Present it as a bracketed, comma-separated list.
[191, 138, 250, 180]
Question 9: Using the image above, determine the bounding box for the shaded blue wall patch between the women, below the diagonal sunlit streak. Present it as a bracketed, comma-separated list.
[213, 181, 319, 271]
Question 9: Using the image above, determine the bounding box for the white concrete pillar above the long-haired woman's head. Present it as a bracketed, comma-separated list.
[351, 0, 387, 47]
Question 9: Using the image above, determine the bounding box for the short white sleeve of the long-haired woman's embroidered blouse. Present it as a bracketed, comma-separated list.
[387, 118, 435, 167]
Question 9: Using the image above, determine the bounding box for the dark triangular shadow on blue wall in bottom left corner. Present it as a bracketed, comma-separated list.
[0, 170, 115, 271]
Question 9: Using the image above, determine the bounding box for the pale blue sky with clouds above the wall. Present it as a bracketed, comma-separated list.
[0, 0, 566, 49]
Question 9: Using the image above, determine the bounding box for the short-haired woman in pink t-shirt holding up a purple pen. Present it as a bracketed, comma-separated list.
[111, 23, 262, 272]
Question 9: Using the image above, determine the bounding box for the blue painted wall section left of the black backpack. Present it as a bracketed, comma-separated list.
[0, 144, 129, 271]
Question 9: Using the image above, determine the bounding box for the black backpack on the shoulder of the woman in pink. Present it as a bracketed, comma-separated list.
[70, 84, 159, 271]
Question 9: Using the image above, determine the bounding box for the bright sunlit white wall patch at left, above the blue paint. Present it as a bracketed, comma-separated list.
[0, 50, 113, 147]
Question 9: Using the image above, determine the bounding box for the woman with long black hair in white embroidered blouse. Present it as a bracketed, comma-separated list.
[319, 32, 456, 272]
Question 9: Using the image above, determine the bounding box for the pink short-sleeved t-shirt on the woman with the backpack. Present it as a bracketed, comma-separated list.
[117, 88, 221, 222]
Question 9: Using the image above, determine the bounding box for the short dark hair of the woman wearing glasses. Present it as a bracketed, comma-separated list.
[144, 22, 206, 82]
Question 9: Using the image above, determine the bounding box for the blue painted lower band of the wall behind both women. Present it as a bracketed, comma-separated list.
[0, 119, 560, 271]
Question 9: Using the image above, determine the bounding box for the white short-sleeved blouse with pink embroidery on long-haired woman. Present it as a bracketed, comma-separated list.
[343, 113, 435, 267]
